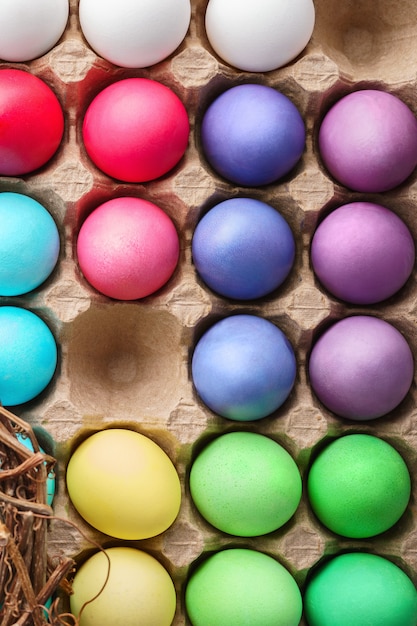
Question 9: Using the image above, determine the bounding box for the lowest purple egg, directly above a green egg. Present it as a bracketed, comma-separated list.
[309, 315, 414, 420]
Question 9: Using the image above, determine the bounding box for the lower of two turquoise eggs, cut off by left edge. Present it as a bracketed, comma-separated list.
[0, 306, 57, 406]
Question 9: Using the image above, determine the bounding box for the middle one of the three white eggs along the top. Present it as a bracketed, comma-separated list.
[79, 0, 191, 68]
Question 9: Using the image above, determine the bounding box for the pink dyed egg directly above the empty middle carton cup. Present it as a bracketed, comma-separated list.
[77, 197, 179, 300]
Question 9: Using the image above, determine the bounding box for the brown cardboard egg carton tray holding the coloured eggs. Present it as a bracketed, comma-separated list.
[0, 0, 417, 626]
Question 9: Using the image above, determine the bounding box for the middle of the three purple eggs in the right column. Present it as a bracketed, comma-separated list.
[311, 202, 415, 304]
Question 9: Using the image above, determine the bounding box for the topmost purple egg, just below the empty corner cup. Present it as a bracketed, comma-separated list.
[319, 89, 417, 192]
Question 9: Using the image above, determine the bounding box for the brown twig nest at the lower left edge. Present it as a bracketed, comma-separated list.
[0, 406, 77, 626]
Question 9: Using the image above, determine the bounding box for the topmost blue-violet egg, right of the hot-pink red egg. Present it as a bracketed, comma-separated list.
[201, 84, 305, 187]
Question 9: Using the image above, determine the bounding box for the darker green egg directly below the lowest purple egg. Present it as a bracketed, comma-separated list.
[307, 434, 411, 539]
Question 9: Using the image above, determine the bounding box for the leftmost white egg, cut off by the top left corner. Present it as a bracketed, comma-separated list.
[0, 0, 69, 62]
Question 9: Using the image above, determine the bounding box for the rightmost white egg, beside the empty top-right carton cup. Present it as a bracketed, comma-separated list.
[205, 0, 315, 72]
